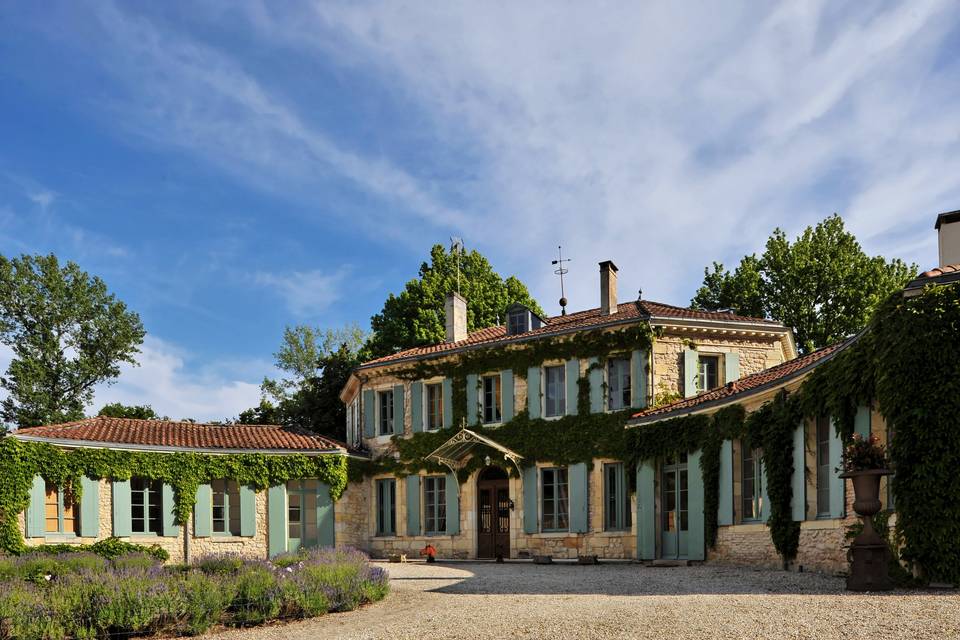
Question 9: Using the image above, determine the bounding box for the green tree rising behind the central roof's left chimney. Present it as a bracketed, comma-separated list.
[362, 244, 543, 360]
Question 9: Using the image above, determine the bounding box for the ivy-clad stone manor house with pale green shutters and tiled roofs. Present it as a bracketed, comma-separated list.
[10, 212, 960, 571]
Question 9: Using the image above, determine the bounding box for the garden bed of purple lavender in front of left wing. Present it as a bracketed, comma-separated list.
[0, 549, 389, 640]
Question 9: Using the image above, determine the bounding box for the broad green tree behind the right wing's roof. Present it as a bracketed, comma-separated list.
[691, 214, 917, 353]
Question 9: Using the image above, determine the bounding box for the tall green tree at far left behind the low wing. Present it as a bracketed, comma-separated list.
[0, 254, 145, 427]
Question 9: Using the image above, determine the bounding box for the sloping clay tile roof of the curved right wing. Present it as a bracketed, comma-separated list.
[628, 338, 854, 424]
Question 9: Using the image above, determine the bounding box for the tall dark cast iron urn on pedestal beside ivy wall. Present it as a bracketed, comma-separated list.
[840, 469, 893, 591]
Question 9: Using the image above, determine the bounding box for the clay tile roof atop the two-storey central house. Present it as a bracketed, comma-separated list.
[360, 300, 785, 368]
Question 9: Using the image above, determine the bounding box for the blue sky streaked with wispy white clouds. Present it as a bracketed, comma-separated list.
[0, 1, 960, 419]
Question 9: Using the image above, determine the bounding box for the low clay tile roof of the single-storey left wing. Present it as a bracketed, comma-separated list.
[13, 416, 347, 453]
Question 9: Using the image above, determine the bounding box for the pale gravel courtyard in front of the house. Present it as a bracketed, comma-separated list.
[208, 563, 960, 640]
